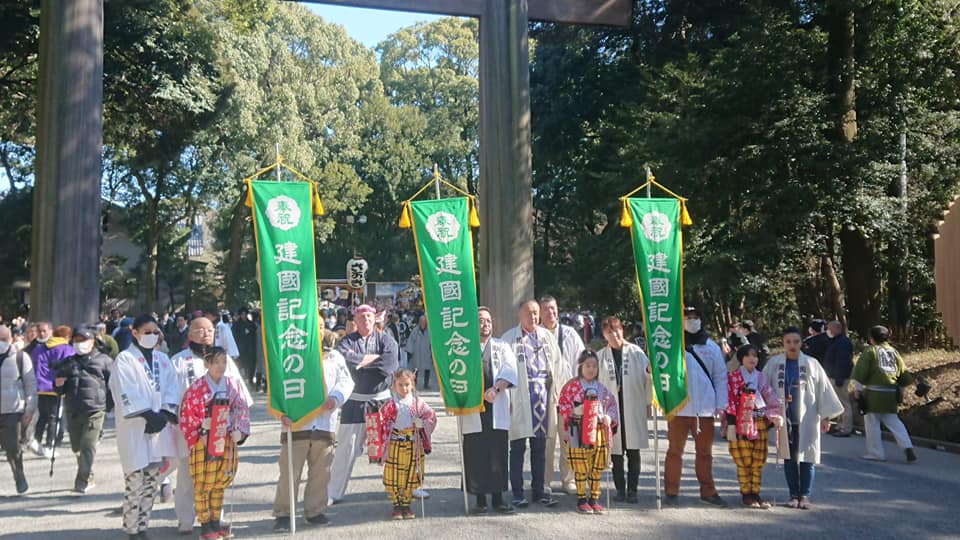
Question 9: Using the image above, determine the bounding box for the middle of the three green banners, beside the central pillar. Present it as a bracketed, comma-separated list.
[410, 197, 483, 415]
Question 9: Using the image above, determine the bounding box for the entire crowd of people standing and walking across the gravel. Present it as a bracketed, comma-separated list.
[0, 296, 917, 540]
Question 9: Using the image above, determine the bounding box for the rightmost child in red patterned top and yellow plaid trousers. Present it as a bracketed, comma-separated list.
[726, 345, 783, 509]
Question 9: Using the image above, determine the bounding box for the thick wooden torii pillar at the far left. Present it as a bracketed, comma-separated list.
[30, 0, 103, 325]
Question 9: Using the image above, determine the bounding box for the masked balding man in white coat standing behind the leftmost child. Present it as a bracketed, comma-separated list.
[170, 317, 253, 534]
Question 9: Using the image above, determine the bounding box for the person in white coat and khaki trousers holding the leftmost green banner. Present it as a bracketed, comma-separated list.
[273, 330, 353, 532]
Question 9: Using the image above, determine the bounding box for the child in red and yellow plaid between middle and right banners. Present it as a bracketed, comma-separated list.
[558, 349, 620, 514]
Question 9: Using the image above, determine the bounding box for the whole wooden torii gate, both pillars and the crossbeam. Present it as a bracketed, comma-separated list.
[31, 0, 632, 328]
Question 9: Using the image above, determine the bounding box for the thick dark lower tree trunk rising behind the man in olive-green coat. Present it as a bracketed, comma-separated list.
[840, 227, 880, 337]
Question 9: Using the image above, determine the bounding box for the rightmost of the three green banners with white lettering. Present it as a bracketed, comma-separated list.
[627, 199, 687, 418]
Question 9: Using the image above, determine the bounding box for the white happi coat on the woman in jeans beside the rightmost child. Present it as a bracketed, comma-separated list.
[763, 353, 843, 463]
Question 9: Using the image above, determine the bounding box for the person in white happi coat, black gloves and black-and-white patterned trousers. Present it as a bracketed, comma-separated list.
[110, 315, 180, 539]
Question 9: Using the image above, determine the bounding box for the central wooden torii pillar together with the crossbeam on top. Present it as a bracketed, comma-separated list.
[308, 0, 632, 324]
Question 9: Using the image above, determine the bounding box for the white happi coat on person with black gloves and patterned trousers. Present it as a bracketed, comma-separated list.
[110, 345, 183, 474]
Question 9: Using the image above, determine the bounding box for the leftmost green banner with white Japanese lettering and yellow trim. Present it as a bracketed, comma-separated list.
[247, 182, 326, 427]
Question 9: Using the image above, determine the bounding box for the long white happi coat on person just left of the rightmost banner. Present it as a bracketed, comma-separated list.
[597, 343, 653, 455]
